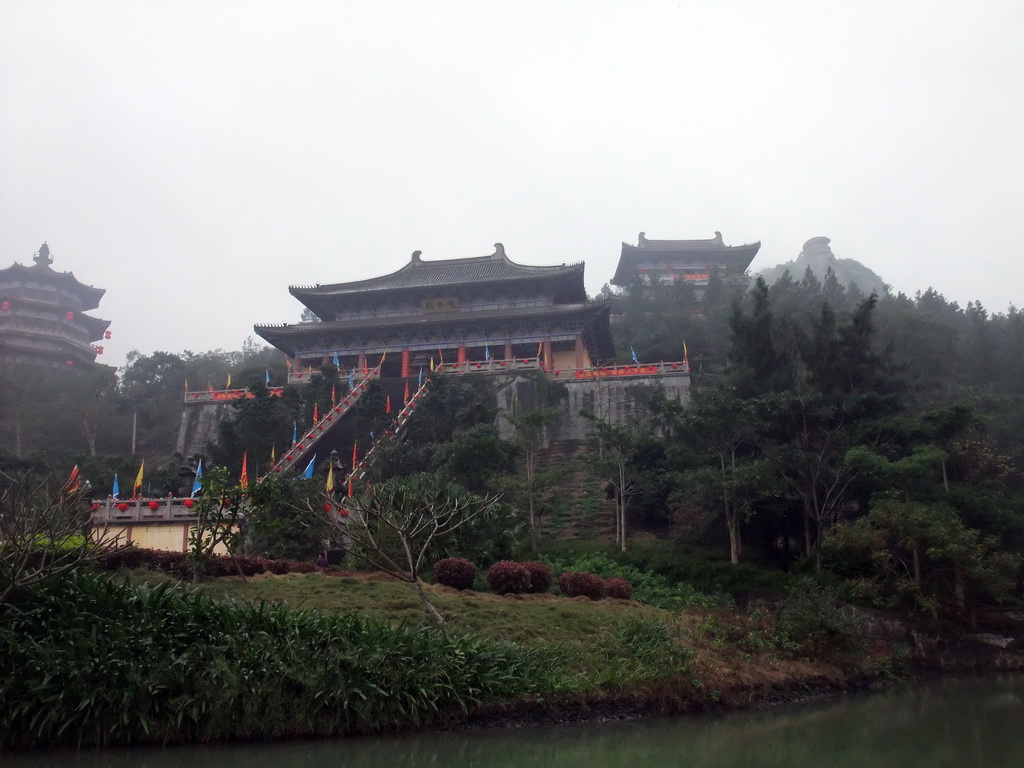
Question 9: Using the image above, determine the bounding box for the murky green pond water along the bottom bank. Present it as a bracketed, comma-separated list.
[8, 675, 1024, 768]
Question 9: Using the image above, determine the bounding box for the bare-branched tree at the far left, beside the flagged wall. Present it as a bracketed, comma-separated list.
[0, 471, 120, 605]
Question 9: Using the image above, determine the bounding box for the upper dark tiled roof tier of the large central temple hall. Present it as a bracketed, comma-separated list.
[289, 243, 586, 303]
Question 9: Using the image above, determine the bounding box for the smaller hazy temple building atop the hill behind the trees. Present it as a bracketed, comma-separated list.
[611, 231, 761, 295]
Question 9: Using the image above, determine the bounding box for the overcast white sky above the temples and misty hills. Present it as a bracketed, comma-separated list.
[0, 0, 1024, 365]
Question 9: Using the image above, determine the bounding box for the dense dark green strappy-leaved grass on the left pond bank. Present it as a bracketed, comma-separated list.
[0, 573, 549, 748]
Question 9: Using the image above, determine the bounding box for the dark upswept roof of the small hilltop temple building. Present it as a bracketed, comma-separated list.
[611, 231, 761, 286]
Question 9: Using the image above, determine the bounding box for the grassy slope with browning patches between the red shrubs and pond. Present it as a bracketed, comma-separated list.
[186, 573, 872, 711]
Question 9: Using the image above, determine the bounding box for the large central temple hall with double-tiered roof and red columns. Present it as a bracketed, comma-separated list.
[254, 243, 614, 377]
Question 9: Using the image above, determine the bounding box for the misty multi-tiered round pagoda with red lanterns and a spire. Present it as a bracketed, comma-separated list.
[0, 243, 111, 366]
